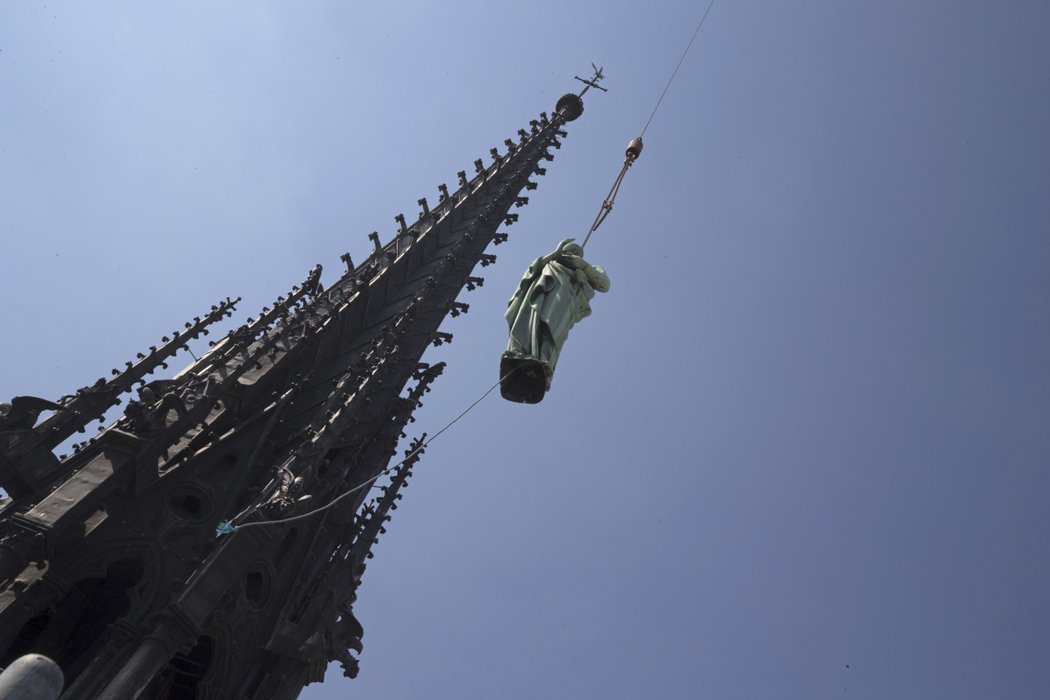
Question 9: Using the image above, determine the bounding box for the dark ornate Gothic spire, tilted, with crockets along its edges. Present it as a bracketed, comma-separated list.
[0, 81, 593, 700]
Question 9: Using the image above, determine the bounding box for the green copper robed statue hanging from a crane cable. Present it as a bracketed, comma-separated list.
[500, 238, 609, 403]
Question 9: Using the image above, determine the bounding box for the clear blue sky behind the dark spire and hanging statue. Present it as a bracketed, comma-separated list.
[0, 0, 1050, 700]
